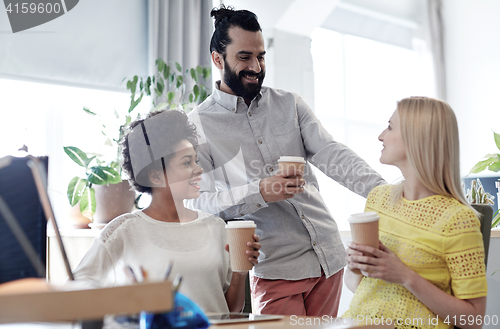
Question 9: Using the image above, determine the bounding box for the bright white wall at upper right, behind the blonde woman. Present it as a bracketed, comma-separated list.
[443, 0, 500, 176]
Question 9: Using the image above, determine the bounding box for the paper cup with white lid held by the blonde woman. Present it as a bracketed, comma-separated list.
[348, 211, 380, 274]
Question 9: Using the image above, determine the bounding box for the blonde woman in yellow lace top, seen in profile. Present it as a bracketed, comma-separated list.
[343, 97, 487, 329]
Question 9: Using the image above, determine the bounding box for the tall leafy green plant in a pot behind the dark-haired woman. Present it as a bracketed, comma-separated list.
[64, 58, 211, 222]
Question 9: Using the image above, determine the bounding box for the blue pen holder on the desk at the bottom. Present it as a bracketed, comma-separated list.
[140, 293, 210, 329]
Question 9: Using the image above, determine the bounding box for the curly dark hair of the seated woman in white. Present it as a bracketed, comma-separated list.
[120, 110, 198, 194]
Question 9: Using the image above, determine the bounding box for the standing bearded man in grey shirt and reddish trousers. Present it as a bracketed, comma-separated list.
[189, 6, 385, 316]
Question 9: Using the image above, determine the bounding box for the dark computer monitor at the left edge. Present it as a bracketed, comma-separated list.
[0, 157, 48, 283]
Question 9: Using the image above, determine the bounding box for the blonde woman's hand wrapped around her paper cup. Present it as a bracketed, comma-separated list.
[347, 241, 416, 286]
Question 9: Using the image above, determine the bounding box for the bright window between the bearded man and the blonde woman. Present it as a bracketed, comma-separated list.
[311, 28, 434, 230]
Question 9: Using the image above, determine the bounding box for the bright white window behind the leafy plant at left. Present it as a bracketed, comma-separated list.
[0, 79, 149, 218]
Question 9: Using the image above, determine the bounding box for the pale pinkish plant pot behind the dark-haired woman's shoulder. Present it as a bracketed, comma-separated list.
[92, 181, 135, 224]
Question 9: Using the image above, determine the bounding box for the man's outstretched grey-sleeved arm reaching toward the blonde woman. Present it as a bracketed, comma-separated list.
[296, 96, 387, 198]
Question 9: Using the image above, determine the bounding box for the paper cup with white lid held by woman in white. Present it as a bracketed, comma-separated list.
[226, 220, 256, 272]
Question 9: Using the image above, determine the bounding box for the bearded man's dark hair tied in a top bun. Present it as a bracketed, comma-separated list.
[210, 5, 262, 58]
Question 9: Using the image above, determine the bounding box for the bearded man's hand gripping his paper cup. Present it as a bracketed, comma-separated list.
[259, 167, 306, 203]
